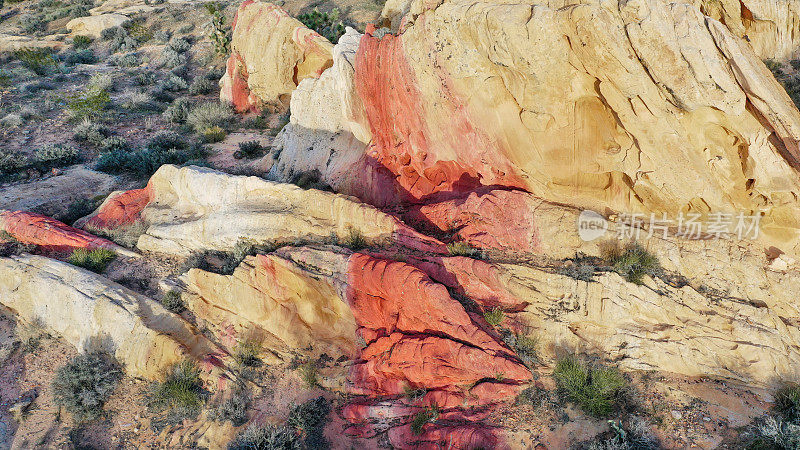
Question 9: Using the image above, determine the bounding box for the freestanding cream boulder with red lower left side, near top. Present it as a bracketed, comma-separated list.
[220, 0, 333, 111]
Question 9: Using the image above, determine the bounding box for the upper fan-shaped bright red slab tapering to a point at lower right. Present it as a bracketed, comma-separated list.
[347, 253, 513, 356]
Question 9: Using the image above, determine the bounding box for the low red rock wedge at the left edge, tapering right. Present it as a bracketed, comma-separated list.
[0, 211, 132, 254]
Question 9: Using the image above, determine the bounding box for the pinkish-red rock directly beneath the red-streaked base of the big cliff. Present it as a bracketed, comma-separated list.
[404, 189, 541, 253]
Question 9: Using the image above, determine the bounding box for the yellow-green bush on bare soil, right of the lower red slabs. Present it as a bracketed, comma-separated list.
[553, 357, 627, 417]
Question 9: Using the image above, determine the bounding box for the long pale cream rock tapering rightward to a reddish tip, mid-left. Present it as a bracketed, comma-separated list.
[132, 165, 443, 255]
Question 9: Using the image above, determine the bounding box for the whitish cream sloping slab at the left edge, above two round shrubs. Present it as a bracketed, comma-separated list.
[0, 255, 225, 380]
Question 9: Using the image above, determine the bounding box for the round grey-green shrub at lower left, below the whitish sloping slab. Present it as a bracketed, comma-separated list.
[53, 352, 122, 421]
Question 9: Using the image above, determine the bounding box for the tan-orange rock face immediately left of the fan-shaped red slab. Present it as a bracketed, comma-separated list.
[184, 255, 357, 359]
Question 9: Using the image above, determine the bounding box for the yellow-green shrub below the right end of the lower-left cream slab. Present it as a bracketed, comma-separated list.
[148, 359, 203, 423]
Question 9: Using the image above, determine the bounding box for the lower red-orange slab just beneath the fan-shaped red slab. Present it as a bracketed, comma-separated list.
[350, 331, 531, 401]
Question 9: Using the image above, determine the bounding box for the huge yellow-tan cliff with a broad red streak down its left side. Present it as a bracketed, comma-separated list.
[271, 0, 800, 253]
